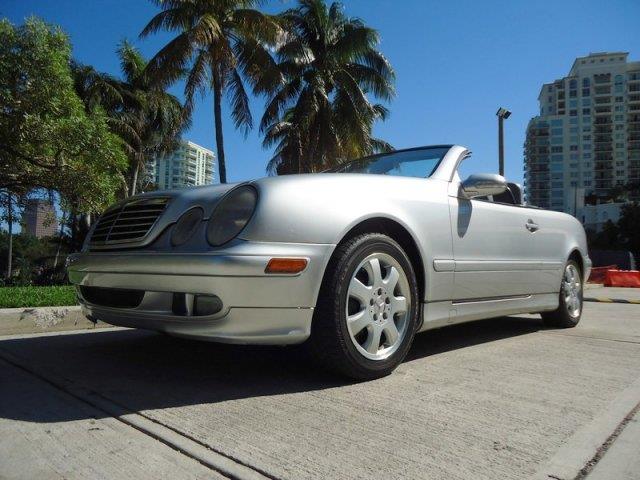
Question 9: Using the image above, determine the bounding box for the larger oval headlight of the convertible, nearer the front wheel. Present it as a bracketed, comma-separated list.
[207, 185, 258, 247]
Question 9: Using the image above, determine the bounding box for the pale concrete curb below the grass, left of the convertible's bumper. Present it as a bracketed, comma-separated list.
[0, 305, 109, 335]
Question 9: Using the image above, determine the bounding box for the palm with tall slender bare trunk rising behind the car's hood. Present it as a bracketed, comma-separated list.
[140, 0, 282, 183]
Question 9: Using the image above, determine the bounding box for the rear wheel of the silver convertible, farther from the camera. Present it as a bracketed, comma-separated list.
[542, 260, 583, 328]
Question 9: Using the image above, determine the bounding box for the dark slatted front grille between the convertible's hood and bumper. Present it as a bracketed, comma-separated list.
[90, 198, 169, 247]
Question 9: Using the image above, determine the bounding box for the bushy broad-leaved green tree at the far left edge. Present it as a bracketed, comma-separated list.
[0, 18, 126, 212]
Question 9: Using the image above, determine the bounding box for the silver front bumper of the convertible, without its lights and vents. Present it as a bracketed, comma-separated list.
[69, 242, 335, 345]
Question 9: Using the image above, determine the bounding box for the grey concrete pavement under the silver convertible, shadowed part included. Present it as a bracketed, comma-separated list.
[0, 303, 640, 479]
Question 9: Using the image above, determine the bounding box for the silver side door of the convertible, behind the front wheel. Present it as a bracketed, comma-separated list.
[449, 181, 544, 300]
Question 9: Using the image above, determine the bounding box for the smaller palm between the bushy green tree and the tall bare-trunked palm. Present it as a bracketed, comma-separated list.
[72, 40, 188, 196]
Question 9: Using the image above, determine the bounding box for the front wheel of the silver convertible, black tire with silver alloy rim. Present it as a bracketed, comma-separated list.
[309, 233, 420, 380]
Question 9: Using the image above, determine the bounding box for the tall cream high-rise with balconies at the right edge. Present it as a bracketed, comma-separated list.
[524, 52, 640, 222]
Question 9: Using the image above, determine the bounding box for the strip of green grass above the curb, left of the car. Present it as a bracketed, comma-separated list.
[0, 285, 78, 308]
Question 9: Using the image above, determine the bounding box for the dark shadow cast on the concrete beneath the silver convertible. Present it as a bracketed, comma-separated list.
[0, 317, 542, 422]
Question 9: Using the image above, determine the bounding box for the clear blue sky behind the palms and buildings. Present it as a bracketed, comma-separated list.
[5, 0, 640, 186]
